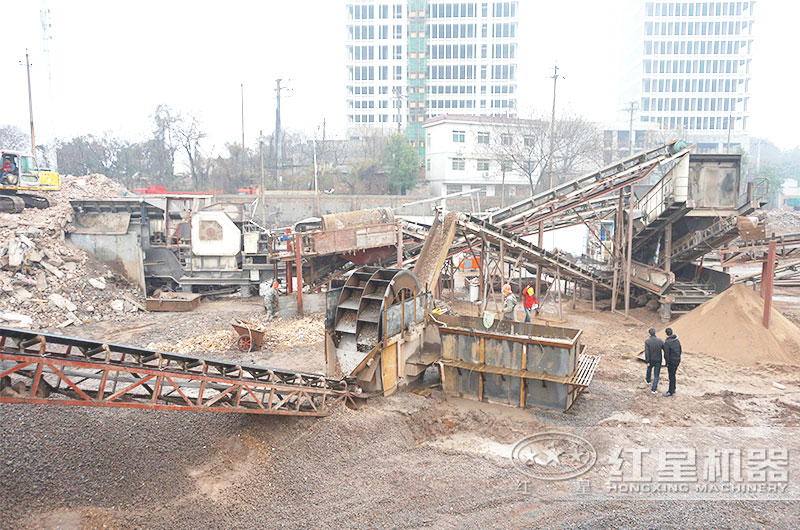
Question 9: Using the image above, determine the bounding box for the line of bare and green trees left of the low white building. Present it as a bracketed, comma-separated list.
[0, 105, 421, 194]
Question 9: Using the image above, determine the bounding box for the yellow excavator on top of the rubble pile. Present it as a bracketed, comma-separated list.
[0, 150, 61, 213]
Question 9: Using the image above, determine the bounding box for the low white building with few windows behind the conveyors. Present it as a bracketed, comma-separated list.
[422, 114, 540, 198]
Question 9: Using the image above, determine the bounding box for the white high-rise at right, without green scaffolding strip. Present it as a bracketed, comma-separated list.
[626, 0, 755, 150]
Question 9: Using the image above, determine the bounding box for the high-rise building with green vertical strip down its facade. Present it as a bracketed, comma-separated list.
[346, 0, 518, 151]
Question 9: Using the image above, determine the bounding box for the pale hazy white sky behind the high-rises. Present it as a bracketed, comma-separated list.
[0, 0, 800, 151]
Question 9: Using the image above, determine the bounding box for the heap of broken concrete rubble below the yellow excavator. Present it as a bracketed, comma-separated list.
[0, 174, 143, 328]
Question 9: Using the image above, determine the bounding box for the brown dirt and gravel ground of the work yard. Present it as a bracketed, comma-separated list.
[0, 290, 800, 528]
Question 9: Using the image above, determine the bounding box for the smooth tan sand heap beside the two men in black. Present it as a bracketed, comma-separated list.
[661, 284, 800, 365]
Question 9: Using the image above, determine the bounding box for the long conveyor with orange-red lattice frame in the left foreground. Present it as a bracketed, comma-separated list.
[0, 327, 354, 416]
